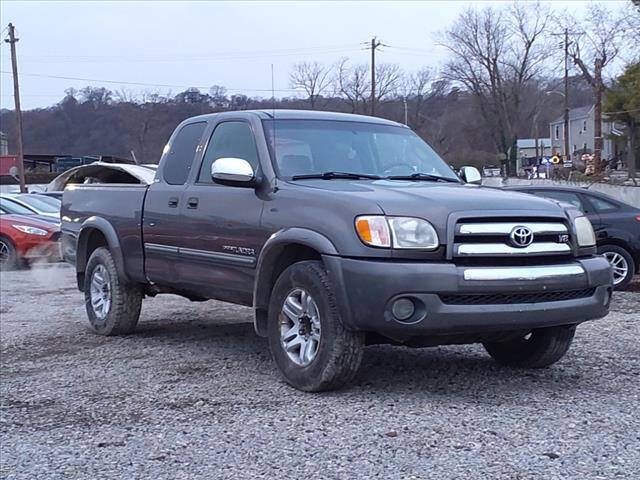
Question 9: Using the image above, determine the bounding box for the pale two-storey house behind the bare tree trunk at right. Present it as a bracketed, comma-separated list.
[549, 105, 624, 160]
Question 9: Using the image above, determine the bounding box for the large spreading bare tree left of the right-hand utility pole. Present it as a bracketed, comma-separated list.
[441, 3, 550, 172]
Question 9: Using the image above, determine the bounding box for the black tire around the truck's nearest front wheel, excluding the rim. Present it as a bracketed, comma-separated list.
[268, 261, 365, 392]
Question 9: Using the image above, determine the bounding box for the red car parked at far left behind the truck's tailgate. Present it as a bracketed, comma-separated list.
[0, 212, 60, 270]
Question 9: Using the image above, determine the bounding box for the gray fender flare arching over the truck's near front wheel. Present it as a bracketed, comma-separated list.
[253, 228, 338, 336]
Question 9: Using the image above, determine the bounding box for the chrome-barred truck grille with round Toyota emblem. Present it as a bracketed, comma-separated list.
[452, 218, 572, 259]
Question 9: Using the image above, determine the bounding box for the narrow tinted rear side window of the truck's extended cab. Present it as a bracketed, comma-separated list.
[164, 122, 207, 185]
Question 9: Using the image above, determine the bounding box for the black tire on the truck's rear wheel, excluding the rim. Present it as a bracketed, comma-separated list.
[84, 247, 143, 335]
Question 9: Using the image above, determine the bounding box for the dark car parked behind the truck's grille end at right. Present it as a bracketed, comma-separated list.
[506, 185, 640, 288]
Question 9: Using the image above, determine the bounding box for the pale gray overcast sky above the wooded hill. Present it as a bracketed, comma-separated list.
[0, 0, 624, 110]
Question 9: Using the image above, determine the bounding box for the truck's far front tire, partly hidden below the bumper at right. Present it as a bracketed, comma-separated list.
[483, 326, 576, 368]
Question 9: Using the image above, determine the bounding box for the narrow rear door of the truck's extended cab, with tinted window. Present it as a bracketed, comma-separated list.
[142, 122, 207, 285]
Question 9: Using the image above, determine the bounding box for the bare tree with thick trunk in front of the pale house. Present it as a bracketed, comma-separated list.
[565, 3, 627, 171]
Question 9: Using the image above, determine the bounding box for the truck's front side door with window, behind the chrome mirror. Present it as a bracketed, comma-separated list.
[177, 120, 266, 305]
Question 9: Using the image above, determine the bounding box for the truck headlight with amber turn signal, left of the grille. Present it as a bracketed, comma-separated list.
[356, 215, 439, 250]
